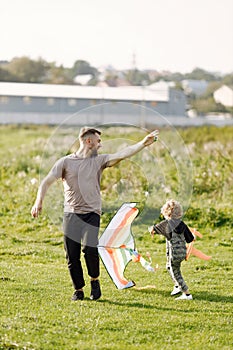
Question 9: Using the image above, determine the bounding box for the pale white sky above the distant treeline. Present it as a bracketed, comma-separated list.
[0, 0, 233, 74]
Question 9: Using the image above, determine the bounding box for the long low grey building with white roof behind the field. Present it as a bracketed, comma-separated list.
[0, 82, 186, 125]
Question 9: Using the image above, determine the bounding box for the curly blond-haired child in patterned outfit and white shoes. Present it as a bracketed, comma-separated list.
[149, 199, 195, 300]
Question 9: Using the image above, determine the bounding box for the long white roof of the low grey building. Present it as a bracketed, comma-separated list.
[0, 82, 169, 102]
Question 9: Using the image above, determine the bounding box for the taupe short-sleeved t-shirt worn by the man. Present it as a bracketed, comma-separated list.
[50, 154, 109, 215]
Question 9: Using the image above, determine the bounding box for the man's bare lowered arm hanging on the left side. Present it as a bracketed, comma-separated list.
[31, 173, 57, 218]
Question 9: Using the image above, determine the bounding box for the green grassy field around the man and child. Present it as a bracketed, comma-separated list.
[0, 126, 233, 350]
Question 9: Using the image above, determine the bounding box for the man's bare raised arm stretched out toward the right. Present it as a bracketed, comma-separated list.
[107, 130, 159, 167]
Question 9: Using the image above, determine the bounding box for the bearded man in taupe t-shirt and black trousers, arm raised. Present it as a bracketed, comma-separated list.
[31, 127, 159, 301]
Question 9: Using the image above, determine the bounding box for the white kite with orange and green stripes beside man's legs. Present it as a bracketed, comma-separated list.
[98, 203, 155, 289]
